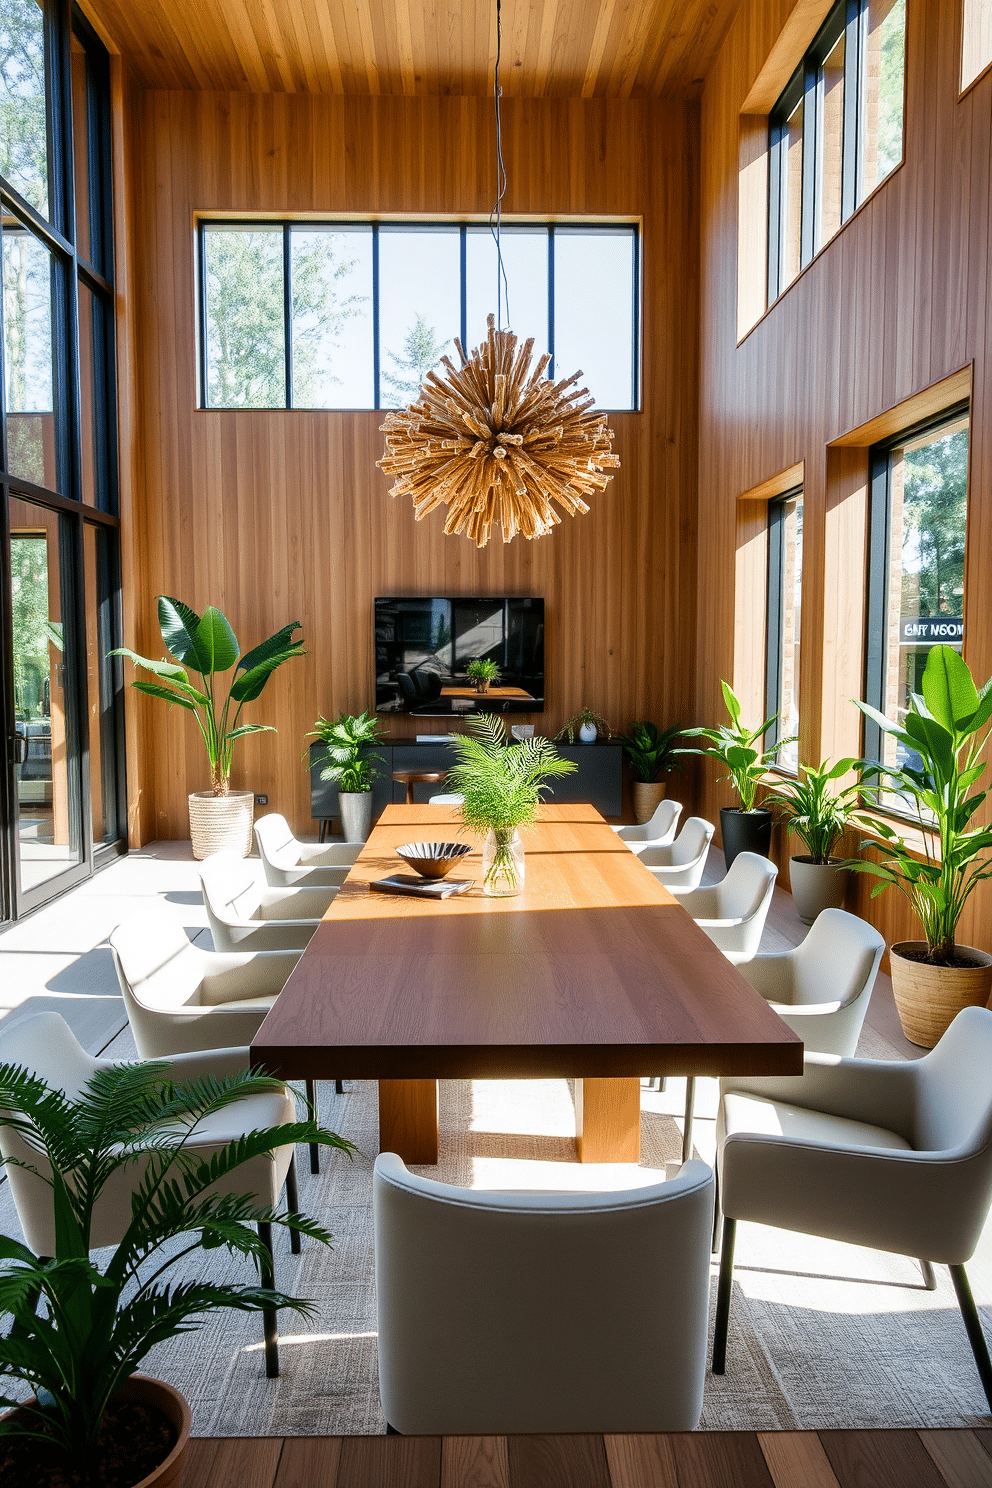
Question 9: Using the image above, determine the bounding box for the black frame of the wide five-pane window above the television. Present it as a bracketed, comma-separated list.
[195, 216, 642, 414]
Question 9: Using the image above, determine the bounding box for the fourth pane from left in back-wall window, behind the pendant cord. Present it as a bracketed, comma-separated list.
[466, 228, 547, 357]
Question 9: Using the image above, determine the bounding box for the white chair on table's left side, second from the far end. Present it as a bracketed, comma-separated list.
[199, 853, 338, 951]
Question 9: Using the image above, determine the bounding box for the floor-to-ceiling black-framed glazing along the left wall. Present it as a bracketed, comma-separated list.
[0, 0, 125, 920]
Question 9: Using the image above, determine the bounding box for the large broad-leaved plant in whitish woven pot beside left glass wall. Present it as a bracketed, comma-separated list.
[109, 594, 303, 859]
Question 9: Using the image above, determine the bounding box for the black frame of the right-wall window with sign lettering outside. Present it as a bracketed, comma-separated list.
[861, 399, 971, 773]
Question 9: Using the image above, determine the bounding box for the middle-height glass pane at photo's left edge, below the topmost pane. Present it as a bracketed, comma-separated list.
[3, 220, 57, 490]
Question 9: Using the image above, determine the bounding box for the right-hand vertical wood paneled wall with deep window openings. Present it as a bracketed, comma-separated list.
[696, 0, 992, 948]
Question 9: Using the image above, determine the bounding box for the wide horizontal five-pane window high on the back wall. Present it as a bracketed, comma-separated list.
[197, 217, 640, 409]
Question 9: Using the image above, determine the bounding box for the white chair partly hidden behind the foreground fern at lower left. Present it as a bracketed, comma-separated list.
[0, 1013, 300, 1378]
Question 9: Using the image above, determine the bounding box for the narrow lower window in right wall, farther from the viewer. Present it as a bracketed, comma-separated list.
[764, 487, 803, 774]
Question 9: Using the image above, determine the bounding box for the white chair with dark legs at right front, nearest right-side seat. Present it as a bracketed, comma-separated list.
[712, 1007, 992, 1406]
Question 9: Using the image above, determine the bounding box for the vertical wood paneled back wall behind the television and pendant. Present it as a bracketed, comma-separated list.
[125, 92, 699, 839]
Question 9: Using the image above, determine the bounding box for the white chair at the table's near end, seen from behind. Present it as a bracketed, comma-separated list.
[372, 1153, 712, 1436]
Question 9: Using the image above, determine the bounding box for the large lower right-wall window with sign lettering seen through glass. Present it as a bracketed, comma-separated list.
[864, 406, 968, 809]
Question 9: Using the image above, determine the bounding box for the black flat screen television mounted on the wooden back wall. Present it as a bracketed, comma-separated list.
[375, 595, 544, 717]
